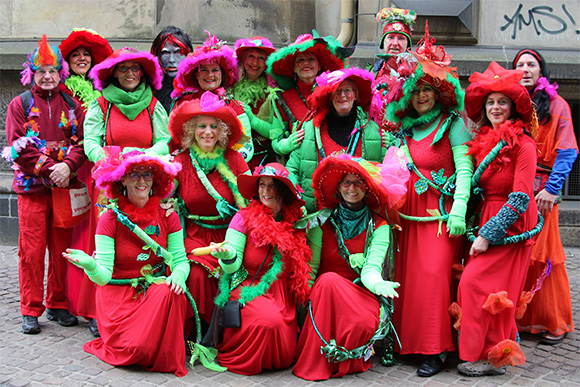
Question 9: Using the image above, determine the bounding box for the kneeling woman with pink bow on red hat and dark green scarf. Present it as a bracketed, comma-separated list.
[293, 152, 409, 380]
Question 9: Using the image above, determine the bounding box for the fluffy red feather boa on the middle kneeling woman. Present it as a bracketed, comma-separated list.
[242, 200, 312, 304]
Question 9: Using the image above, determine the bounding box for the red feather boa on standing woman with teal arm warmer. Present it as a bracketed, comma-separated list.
[467, 120, 525, 171]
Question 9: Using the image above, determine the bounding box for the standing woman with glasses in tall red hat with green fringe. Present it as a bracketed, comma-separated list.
[386, 25, 473, 377]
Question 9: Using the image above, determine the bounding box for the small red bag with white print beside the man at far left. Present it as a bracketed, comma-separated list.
[51, 183, 91, 228]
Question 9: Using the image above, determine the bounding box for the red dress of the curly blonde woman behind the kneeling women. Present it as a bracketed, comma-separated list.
[175, 149, 248, 322]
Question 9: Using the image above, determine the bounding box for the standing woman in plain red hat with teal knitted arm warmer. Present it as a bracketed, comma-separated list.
[456, 62, 538, 376]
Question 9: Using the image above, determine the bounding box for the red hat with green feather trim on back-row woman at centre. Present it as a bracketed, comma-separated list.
[266, 30, 353, 90]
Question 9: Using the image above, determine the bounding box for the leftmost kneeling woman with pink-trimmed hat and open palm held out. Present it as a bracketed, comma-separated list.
[63, 147, 189, 376]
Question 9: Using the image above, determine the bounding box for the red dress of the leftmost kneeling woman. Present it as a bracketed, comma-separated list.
[83, 203, 189, 376]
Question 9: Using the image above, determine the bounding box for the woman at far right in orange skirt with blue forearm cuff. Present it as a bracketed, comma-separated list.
[513, 49, 578, 344]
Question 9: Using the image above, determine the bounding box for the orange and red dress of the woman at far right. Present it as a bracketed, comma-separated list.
[517, 95, 578, 335]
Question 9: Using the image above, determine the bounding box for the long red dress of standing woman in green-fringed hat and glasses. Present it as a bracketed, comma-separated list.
[393, 123, 462, 355]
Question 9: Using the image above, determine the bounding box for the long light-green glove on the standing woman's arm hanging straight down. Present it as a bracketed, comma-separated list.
[447, 145, 473, 235]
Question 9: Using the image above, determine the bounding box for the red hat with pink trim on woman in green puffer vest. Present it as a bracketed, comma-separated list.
[308, 67, 374, 125]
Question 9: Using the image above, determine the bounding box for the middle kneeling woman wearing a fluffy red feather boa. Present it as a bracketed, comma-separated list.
[212, 163, 311, 375]
